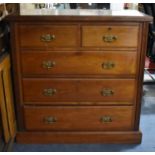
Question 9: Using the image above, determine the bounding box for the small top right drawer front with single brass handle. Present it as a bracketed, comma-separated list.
[82, 25, 139, 47]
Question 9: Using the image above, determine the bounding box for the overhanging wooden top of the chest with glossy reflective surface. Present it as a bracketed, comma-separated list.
[6, 9, 153, 23]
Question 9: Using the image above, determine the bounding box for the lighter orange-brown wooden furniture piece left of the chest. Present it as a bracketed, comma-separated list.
[0, 54, 16, 143]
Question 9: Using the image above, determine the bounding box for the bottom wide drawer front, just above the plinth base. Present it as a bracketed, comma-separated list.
[24, 106, 134, 131]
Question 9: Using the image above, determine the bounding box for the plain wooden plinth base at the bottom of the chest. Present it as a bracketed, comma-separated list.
[17, 131, 142, 144]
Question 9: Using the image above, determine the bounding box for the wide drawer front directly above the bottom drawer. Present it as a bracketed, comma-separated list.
[23, 79, 135, 104]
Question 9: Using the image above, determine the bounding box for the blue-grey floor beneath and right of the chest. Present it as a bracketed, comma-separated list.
[13, 84, 155, 152]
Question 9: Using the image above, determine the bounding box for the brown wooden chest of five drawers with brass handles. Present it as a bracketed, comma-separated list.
[8, 10, 152, 143]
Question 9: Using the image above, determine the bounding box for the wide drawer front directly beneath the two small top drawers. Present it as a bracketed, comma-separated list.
[22, 51, 137, 76]
